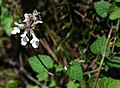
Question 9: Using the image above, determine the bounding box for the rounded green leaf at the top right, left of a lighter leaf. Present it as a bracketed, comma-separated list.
[94, 1, 111, 18]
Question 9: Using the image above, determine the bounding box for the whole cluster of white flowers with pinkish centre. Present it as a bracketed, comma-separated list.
[11, 10, 43, 48]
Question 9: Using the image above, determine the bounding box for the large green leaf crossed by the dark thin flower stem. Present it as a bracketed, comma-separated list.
[28, 55, 53, 73]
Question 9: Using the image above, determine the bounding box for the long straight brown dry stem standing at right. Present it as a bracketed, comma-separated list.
[93, 27, 113, 88]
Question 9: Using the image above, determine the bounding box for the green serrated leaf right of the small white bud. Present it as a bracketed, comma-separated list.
[67, 61, 83, 80]
